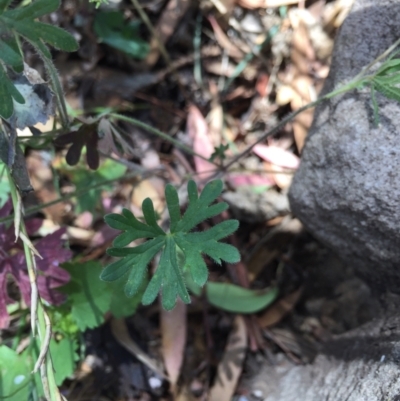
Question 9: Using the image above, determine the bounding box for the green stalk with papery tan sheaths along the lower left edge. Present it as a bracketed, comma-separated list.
[7, 169, 63, 401]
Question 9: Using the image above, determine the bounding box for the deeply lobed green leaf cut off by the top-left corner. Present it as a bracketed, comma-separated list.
[0, 0, 78, 118]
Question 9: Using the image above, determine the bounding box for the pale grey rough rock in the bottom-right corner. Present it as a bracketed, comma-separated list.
[251, 304, 400, 401]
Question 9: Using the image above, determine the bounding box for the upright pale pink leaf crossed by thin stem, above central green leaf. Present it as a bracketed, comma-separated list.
[187, 105, 215, 179]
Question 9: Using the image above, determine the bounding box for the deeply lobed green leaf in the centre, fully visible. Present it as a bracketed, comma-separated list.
[100, 180, 240, 310]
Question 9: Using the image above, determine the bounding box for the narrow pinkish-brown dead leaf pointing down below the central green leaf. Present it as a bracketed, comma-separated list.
[161, 300, 187, 393]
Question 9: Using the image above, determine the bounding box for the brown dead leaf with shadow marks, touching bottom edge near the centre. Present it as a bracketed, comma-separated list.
[208, 315, 247, 401]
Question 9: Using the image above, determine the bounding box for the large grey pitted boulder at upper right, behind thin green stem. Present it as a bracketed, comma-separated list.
[289, 0, 400, 293]
